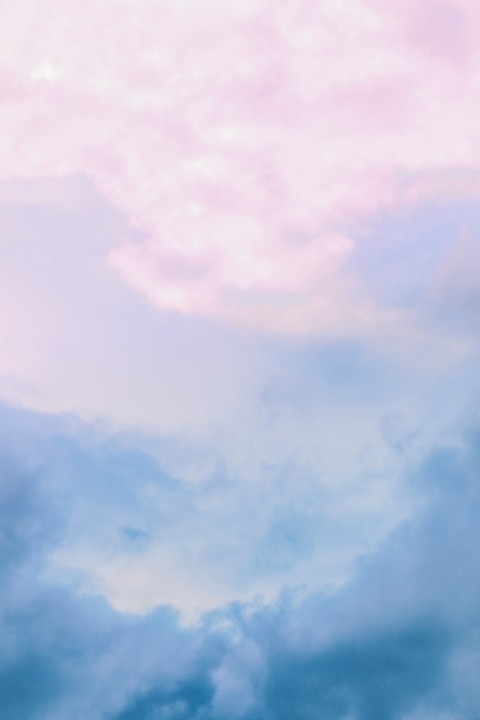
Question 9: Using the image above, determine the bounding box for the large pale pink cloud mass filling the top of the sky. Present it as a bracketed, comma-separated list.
[0, 0, 480, 333]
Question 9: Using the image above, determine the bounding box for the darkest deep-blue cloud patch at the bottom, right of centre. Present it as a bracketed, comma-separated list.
[265, 619, 450, 720]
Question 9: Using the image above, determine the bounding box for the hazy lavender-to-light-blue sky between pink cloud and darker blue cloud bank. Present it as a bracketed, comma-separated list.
[0, 177, 478, 617]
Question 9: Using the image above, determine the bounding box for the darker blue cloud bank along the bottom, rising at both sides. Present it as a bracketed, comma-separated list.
[0, 410, 480, 720]
